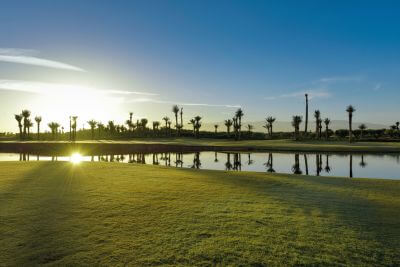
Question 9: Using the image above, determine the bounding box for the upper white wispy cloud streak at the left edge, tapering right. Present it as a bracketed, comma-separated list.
[0, 48, 85, 71]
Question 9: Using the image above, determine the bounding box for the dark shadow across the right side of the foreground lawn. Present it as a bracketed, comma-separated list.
[177, 170, 400, 265]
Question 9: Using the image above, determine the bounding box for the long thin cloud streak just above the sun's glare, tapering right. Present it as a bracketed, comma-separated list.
[0, 79, 157, 96]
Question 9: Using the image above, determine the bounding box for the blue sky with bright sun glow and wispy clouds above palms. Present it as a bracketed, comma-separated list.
[0, 0, 400, 132]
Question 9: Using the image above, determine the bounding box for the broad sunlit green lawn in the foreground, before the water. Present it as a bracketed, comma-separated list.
[0, 162, 400, 265]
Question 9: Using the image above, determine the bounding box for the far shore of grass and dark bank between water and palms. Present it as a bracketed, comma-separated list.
[0, 138, 400, 154]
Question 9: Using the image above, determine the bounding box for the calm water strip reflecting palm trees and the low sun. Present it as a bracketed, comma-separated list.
[0, 152, 400, 179]
